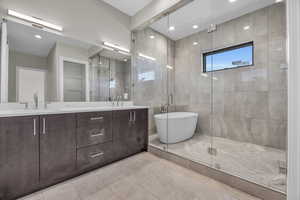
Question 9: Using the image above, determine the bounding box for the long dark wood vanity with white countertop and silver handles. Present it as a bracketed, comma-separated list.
[0, 106, 148, 200]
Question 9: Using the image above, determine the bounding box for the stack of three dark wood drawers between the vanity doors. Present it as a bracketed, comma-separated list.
[77, 111, 113, 171]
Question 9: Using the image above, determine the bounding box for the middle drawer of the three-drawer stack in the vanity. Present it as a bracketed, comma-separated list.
[77, 125, 112, 147]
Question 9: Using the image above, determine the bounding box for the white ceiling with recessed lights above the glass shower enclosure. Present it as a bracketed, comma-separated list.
[151, 0, 275, 40]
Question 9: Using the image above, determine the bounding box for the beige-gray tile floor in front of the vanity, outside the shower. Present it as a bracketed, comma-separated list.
[18, 153, 258, 200]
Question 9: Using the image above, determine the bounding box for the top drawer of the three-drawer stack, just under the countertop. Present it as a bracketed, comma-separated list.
[77, 111, 112, 128]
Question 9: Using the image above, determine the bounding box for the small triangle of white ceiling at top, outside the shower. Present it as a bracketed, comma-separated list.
[102, 0, 152, 16]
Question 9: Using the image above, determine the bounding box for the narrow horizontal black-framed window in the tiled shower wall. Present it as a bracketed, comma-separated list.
[203, 42, 254, 72]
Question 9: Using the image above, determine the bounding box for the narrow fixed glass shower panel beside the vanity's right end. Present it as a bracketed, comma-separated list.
[132, 28, 168, 151]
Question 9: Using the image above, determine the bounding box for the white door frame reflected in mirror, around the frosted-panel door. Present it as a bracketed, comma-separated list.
[58, 56, 90, 102]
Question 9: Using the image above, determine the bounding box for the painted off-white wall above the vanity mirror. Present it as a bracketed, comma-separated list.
[0, 0, 130, 48]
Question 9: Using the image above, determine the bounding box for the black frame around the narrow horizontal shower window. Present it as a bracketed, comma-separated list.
[202, 41, 254, 73]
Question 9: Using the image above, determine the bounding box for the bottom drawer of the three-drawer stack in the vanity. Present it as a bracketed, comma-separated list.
[77, 142, 113, 170]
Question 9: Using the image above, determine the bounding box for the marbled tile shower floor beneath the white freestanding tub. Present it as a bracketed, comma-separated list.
[149, 134, 286, 193]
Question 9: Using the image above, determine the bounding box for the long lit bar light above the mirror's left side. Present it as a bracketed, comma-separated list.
[8, 10, 63, 31]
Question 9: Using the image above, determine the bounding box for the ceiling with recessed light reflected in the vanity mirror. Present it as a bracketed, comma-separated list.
[7, 21, 92, 57]
